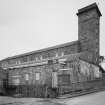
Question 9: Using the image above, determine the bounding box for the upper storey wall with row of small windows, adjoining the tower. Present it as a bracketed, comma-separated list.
[1, 41, 80, 68]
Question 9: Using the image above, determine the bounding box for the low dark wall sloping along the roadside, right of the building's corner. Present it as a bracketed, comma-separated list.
[58, 78, 105, 95]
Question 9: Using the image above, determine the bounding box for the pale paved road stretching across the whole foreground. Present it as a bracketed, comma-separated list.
[0, 91, 105, 105]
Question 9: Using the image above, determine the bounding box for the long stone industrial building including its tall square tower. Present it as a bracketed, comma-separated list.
[0, 3, 101, 97]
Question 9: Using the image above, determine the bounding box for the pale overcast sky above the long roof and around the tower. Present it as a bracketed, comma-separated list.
[0, 0, 105, 60]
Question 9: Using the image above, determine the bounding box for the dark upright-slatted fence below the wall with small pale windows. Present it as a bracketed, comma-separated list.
[8, 85, 46, 98]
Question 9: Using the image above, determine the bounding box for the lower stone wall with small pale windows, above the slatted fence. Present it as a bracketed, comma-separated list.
[8, 65, 51, 86]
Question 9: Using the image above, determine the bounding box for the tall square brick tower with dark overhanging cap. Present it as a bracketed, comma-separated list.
[77, 3, 102, 65]
